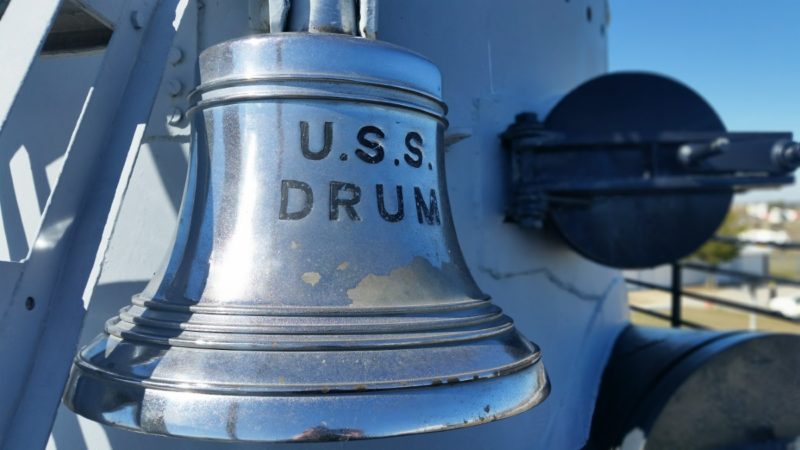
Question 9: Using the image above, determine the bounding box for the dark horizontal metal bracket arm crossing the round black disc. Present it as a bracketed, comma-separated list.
[502, 113, 800, 226]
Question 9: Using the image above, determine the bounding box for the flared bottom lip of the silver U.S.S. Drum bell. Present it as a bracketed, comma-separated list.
[63, 359, 551, 443]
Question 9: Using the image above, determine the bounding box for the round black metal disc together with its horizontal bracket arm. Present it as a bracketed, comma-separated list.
[501, 73, 800, 267]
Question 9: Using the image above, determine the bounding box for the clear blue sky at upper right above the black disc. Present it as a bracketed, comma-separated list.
[609, 0, 800, 202]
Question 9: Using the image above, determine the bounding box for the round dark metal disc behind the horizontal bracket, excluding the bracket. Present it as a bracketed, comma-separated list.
[545, 72, 733, 268]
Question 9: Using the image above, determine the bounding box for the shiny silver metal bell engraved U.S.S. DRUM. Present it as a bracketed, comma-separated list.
[65, 33, 549, 442]
